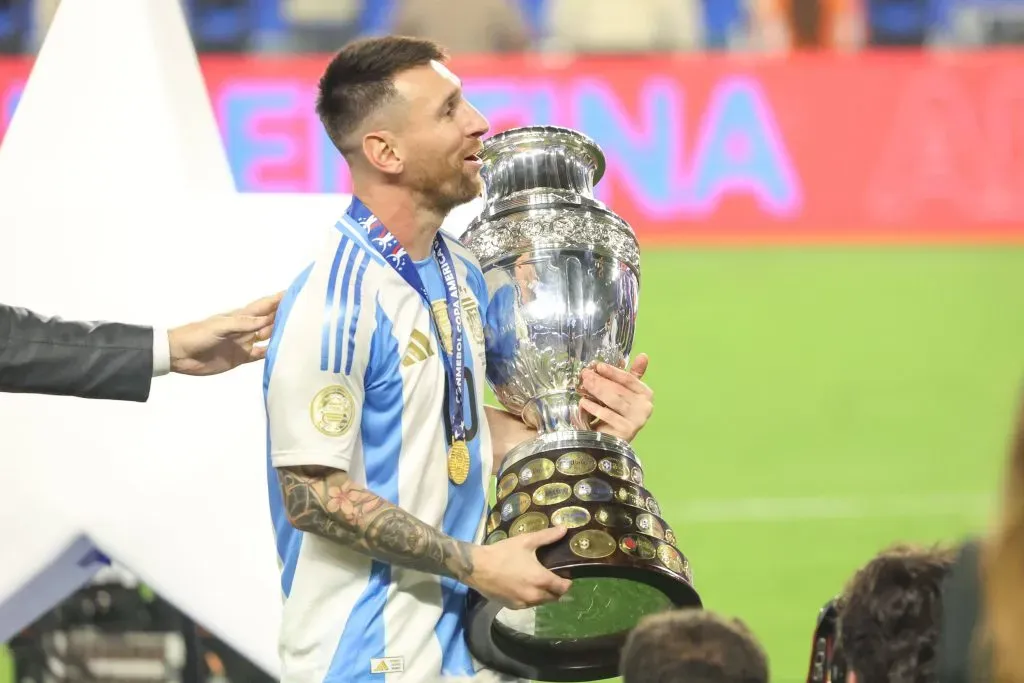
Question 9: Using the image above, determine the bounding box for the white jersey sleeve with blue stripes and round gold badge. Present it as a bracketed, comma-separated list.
[265, 259, 375, 471]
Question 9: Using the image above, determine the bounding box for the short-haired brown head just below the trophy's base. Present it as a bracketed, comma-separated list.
[620, 609, 768, 683]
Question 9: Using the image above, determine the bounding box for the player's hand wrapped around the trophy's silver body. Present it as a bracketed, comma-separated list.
[580, 353, 654, 441]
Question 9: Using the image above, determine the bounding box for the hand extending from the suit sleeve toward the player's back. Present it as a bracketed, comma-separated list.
[167, 292, 284, 375]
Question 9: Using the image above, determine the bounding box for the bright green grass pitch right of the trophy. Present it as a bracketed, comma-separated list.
[0, 248, 1024, 683]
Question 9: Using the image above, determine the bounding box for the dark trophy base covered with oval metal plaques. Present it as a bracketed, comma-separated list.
[467, 431, 701, 682]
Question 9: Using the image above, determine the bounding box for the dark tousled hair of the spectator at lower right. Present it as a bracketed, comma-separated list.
[839, 545, 955, 683]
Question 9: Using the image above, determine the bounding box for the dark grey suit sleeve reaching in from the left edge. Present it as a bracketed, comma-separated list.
[0, 304, 153, 401]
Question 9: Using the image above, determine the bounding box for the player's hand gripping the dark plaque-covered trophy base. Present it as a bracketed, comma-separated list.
[466, 526, 572, 609]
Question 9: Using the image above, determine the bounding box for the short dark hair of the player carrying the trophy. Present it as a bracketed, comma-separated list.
[316, 36, 447, 154]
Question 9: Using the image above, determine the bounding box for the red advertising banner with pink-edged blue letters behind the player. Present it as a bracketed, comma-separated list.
[0, 52, 1024, 243]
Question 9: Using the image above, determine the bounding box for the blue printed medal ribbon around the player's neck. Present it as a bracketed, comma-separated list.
[348, 197, 466, 442]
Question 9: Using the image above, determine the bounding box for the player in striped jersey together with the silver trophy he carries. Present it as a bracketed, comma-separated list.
[264, 37, 698, 683]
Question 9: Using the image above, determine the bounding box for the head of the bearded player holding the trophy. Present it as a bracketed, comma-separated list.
[316, 36, 487, 216]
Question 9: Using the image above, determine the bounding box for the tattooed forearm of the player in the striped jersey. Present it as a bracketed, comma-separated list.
[278, 467, 473, 581]
